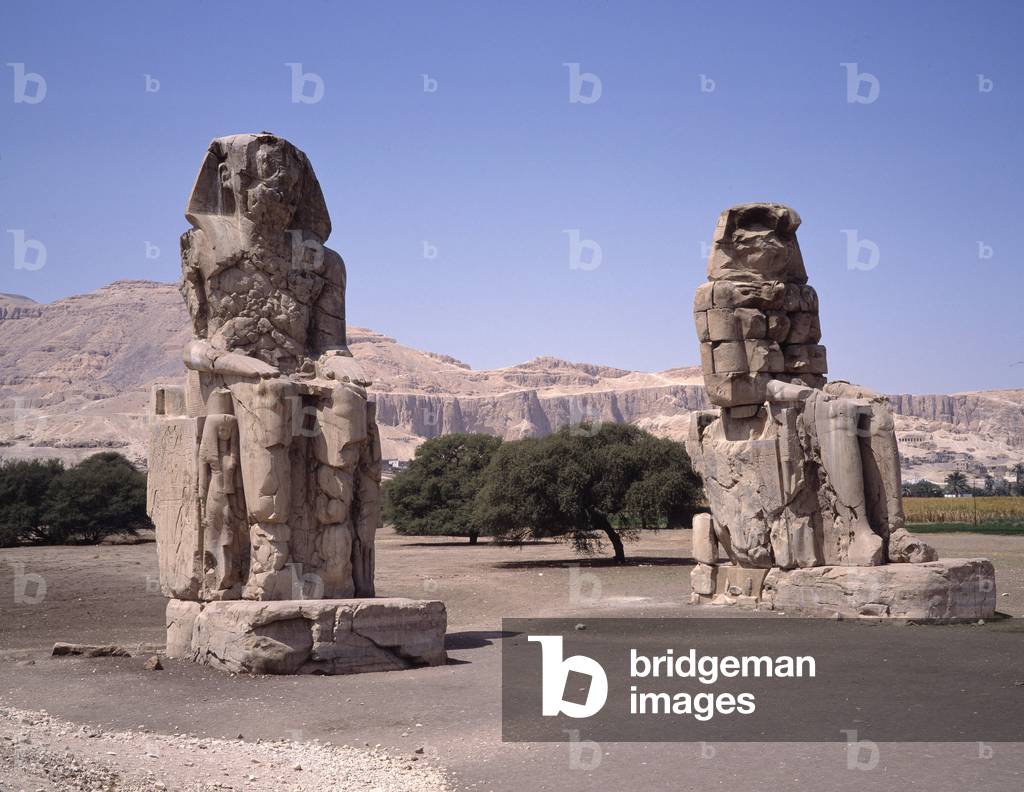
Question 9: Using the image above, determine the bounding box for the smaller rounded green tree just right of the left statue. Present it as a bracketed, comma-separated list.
[384, 433, 502, 544]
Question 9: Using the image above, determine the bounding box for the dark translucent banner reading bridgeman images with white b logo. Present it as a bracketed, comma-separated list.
[502, 617, 1024, 742]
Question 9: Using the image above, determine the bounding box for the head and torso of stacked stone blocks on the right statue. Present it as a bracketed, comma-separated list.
[693, 203, 827, 408]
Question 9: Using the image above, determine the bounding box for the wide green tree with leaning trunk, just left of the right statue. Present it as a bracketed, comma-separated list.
[474, 423, 700, 564]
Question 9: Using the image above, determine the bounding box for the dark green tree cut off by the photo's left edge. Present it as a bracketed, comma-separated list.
[0, 459, 63, 547]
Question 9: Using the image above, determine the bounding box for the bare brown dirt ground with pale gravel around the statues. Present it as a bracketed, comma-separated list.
[0, 531, 1024, 792]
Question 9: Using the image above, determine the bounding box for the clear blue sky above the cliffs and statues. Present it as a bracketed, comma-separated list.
[0, 0, 1024, 392]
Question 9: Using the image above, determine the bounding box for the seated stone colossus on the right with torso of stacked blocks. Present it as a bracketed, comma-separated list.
[687, 204, 994, 618]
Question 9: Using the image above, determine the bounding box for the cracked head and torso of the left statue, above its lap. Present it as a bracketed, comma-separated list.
[181, 132, 345, 374]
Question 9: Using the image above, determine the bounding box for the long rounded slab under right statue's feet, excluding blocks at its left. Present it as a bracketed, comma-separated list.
[762, 558, 995, 621]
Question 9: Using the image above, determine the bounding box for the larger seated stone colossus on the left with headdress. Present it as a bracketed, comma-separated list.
[148, 133, 443, 671]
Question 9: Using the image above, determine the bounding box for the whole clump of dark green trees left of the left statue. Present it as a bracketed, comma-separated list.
[0, 452, 152, 546]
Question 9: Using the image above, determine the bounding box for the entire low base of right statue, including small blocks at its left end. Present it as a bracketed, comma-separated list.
[690, 558, 995, 622]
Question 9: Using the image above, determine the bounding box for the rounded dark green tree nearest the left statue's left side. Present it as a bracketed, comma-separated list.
[37, 451, 153, 544]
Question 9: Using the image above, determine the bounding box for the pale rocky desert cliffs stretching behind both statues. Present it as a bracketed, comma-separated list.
[0, 281, 1024, 480]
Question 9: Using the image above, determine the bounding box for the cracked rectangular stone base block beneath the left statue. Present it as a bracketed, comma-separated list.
[167, 597, 447, 674]
